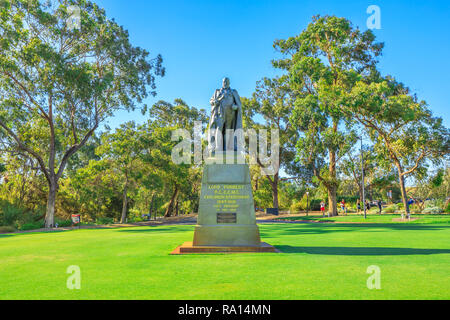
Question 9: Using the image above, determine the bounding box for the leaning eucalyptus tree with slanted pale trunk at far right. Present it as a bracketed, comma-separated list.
[346, 76, 450, 216]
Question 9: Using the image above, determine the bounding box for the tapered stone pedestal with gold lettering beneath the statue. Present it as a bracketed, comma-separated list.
[172, 157, 277, 254]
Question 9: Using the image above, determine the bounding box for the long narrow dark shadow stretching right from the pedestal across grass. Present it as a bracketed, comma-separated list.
[276, 246, 450, 256]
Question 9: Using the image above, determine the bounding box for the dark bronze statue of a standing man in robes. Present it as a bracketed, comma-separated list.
[208, 78, 242, 154]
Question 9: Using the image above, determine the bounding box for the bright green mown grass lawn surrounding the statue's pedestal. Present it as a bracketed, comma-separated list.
[0, 223, 450, 300]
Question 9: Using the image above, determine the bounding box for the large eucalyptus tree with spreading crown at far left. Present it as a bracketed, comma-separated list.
[0, 0, 164, 227]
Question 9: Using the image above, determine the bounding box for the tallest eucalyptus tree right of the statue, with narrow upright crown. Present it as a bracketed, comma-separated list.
[273, 16, 383, 215]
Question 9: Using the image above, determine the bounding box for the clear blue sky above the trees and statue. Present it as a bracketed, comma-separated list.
[96, 0, 450, 127]
